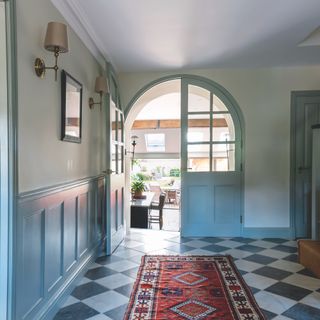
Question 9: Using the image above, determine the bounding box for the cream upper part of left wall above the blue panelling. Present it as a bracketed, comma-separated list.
[16, 0, 104, 192]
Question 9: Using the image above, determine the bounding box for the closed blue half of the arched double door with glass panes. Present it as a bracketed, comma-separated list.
[181, 77, 242, 236]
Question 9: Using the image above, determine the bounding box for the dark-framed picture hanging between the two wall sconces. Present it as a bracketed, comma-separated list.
[61, 70, 82, 143]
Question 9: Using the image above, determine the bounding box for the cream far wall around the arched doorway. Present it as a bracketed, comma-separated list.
[119, 66, 320, 228]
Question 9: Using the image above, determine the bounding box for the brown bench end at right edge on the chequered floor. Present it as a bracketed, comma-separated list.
[298, 239, 320, 278]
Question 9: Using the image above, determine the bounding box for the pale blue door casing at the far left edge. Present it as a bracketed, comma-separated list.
[0, 0, 18, 319]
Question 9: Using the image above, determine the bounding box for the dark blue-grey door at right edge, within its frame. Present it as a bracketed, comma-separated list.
[292, 92, 320, 237]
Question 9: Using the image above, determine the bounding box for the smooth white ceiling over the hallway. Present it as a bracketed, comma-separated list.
[51, 0, 320, 72]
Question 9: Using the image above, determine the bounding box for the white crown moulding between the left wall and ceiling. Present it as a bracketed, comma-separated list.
[51, 0, 111, 68]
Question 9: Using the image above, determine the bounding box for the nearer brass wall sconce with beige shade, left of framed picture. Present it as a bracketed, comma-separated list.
[34, 22, 69, 81]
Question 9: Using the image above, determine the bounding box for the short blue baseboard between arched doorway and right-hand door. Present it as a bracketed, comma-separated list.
[242, 227, 294, 239]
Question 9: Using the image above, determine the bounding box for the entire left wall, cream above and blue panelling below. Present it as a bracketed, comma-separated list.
[14, 0, 107, 320]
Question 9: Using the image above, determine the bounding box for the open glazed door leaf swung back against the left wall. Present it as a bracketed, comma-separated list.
[106, 73, 125, 254]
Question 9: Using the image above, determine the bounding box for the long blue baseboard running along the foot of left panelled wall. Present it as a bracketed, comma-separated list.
[37, 243, 101, 320]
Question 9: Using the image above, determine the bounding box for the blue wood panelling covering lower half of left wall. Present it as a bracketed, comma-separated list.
[15, 176, 105, 320]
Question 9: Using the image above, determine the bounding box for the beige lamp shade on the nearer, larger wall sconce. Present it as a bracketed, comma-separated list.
[44, 22, 69, 52]
